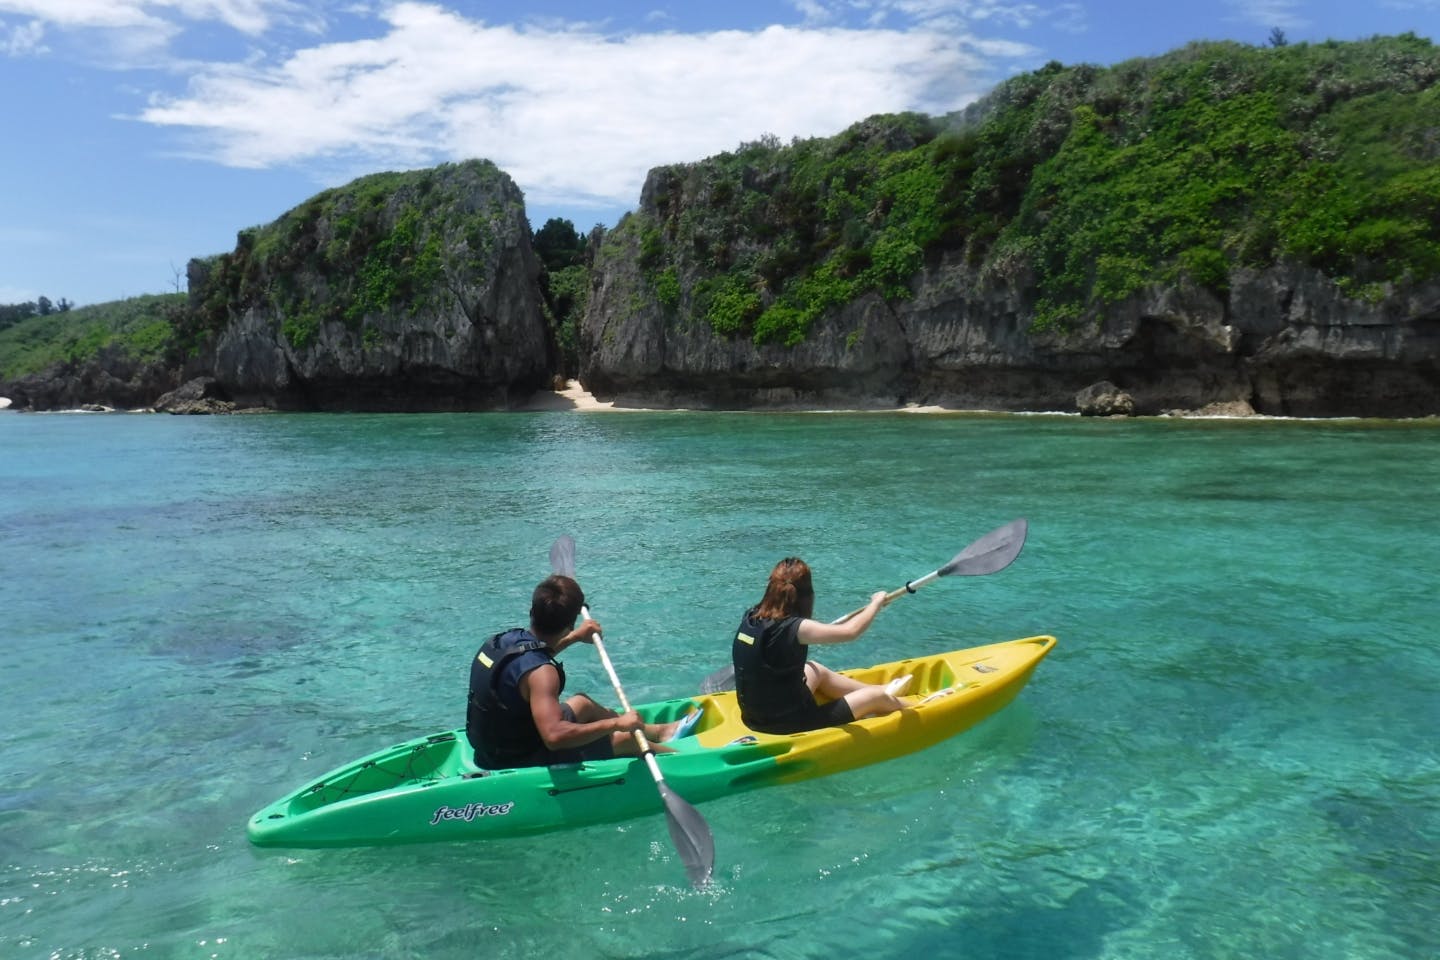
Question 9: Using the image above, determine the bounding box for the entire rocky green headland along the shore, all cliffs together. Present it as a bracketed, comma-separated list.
[0, 35, 1440, 417]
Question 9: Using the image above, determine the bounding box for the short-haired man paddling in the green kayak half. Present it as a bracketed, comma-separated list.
[465, 574, 680, 770]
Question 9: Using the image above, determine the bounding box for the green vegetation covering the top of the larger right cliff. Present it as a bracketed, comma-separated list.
[627, 35, 1440, 344]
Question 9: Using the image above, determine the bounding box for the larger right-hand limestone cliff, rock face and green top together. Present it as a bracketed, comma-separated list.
[580, 35, 1440, 416]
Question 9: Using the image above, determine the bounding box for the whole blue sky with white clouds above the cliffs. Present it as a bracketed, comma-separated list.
[0, 0, 1440, 305]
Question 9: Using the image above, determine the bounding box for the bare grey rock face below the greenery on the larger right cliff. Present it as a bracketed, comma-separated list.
[580, 171, 1440, 417]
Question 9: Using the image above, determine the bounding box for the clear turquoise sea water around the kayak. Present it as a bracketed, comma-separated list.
[0, 413, 1440, 960]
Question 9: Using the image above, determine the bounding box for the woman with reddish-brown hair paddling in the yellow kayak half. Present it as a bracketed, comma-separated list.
[732, 557, 910, 734]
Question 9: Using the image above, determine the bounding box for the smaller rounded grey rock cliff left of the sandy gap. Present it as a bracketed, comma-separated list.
[190, 161, 553, 410]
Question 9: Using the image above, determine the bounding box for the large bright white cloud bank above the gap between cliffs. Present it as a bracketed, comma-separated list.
[140, 3, 1034, 206]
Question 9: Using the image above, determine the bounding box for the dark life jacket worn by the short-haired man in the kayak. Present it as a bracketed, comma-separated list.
[465, 629, 564, 770]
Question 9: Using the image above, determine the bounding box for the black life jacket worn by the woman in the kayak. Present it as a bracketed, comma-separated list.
[730, 609, 815, 730]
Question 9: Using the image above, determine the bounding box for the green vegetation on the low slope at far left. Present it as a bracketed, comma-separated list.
[0, 294, 184, 380]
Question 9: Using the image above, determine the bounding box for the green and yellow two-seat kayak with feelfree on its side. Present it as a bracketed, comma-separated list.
[246, 636, 1056, 846]
